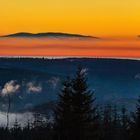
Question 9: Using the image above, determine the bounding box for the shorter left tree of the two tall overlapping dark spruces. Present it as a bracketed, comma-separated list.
[55, 78, 73, 140]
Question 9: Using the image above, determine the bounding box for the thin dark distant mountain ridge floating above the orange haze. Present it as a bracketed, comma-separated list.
[1, 32, 98, 39]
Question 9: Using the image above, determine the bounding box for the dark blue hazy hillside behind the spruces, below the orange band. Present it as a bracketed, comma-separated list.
[0, 58, 140, 113]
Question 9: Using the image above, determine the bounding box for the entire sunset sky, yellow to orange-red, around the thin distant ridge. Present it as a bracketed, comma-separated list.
[0, 0, 140, 57]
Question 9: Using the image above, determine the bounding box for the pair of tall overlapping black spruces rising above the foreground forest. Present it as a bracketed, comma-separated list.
[55, 68, 98, 140]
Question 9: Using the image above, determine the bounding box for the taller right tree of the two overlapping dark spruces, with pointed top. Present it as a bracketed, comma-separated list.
[72, 67, 98, 140]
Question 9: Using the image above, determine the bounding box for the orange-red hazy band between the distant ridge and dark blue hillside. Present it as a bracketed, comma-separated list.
[0, 38, 140, 57]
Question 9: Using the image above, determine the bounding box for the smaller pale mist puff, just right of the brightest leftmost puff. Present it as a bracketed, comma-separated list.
[27, 82, 42, 93]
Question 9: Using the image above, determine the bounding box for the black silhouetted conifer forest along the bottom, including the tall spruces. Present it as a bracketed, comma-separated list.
[0, 68, 140, 140]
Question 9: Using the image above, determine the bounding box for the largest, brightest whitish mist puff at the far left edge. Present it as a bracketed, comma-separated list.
[1, 80, 20, 96]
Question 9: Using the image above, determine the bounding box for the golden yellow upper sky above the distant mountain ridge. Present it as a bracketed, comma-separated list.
[0, 0, 140, 36]
